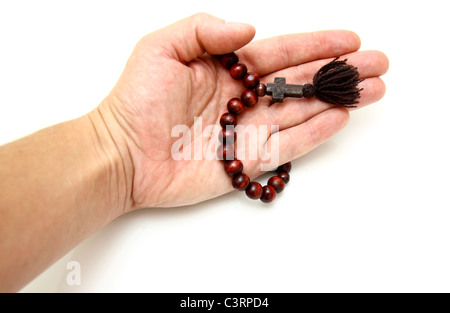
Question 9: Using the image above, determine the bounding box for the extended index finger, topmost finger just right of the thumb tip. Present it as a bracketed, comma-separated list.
[237, 30, 361, 76]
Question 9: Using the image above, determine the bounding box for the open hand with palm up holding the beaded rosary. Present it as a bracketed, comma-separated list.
[97, 14, 388, 211]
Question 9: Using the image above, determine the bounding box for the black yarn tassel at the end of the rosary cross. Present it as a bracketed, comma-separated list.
[303, 58, 363, 108]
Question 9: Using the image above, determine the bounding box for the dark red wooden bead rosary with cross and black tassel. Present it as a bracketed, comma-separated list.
[217, 52, 362, 203]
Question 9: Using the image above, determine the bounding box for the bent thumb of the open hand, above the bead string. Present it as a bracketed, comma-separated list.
[147, 13, 255, 62]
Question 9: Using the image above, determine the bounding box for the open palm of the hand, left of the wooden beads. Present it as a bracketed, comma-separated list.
[107, 50, 268, 207]
